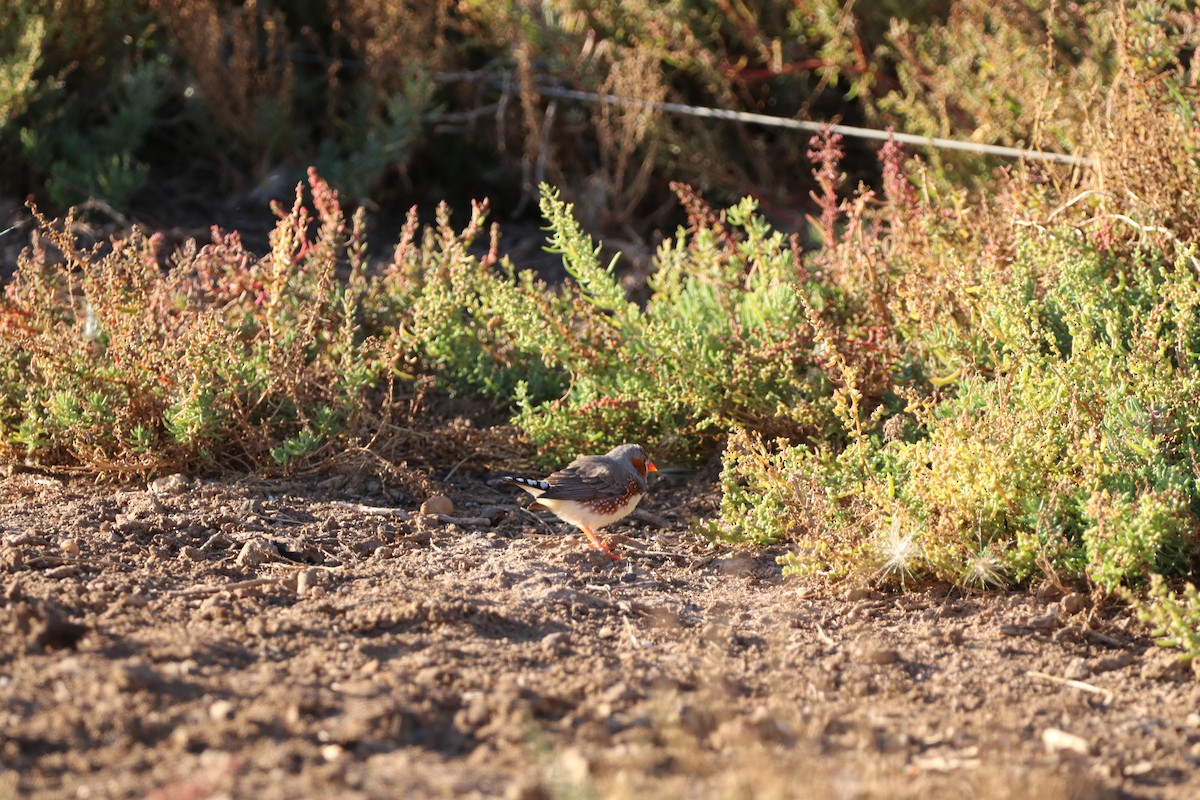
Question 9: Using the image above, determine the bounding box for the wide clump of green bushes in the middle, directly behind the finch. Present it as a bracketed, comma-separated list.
[404, 175, 907, 458]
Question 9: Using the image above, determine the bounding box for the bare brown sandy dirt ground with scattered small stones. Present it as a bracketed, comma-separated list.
[0, 462, 1200, 800]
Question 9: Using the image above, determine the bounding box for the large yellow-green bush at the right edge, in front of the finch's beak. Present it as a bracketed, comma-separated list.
[748, 229, 1200, 591]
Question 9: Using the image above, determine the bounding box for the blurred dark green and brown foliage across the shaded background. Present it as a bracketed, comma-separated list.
[7, 0, 1190, 225]
